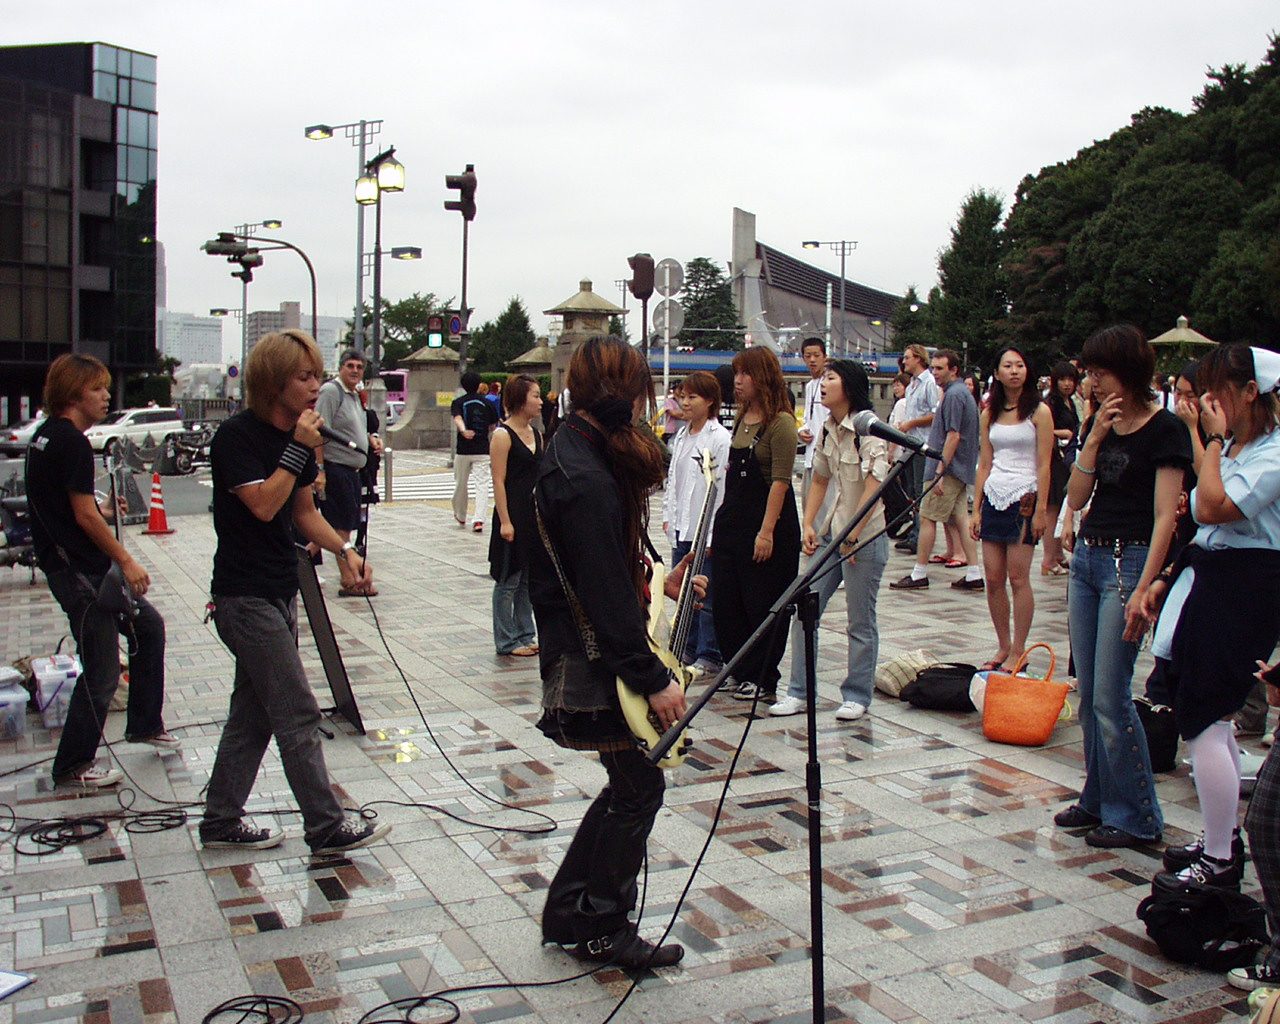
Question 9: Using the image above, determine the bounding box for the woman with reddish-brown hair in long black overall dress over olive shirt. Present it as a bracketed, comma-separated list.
[712, 347, 800, 704]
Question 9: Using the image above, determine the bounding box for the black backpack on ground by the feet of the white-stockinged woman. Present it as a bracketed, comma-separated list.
[1138, 884, 1268, 972]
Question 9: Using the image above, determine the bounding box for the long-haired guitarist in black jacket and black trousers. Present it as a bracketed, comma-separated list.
[530, 338, 701, 968]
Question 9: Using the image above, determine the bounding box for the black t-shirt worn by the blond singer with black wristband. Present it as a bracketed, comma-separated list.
[209, 410, 316, 600]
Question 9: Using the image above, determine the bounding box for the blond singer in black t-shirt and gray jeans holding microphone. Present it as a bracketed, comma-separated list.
[200, 330, 390, 854]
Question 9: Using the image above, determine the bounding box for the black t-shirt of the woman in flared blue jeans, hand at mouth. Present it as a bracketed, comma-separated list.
[1080, 410, 1192, 544]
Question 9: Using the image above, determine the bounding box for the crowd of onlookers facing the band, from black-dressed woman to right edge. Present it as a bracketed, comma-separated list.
[456, 325, 1280, 987]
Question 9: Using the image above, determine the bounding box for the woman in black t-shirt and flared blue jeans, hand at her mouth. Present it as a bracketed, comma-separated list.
[1053, 324, 1192, 847]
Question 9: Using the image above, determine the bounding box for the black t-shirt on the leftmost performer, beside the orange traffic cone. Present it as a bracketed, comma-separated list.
[27, 416, 111, 576]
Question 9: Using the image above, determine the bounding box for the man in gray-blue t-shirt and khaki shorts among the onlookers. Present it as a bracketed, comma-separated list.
[890, 348, 984, 590]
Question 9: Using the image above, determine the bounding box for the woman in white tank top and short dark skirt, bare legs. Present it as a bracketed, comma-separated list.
[970, 348, 1053, 668]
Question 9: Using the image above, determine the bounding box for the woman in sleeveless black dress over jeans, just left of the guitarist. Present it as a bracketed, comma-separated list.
[489, 374, 543, 658]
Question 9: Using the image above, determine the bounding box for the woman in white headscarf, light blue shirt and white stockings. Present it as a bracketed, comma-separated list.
[1143, 344, 1280, 901]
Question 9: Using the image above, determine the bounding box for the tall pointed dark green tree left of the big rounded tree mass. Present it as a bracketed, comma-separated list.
[931, 188, 1006, 365]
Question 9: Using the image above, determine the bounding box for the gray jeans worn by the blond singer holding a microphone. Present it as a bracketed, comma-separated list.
[200, 596, 344, 847]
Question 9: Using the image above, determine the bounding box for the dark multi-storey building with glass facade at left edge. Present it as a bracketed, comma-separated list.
[0, 42, 157, 420]
